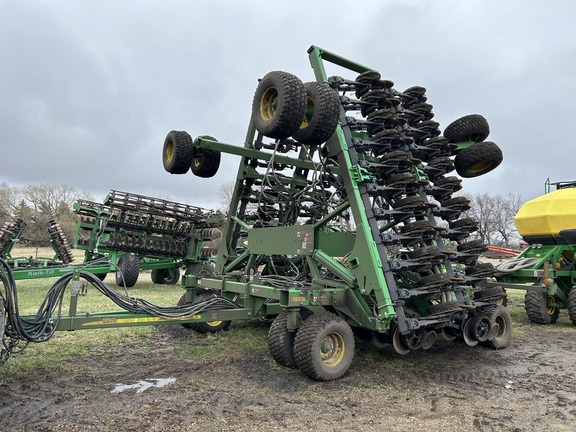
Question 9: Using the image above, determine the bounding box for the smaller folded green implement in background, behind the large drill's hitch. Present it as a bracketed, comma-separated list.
[74, 190, 223, 287]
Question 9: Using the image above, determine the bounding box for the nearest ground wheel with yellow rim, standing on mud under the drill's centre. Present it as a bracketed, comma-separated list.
[294, 312, 355, 381]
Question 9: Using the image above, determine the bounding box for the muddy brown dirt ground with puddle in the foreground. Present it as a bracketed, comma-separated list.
[0, 308, 576, 432]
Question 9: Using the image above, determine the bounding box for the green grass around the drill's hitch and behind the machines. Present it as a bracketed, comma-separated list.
[0, 251, 575, 385]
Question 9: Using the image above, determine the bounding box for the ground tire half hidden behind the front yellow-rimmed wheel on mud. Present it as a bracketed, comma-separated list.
[268, 309, 312, 369]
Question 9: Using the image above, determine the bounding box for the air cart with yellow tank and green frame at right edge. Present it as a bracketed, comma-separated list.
[492, 180, 576, 325]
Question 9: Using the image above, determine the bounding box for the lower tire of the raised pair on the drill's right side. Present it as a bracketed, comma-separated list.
[454, 141, 504, 178]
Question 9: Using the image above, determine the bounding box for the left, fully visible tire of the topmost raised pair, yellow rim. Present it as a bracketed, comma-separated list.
[252, 71, 306, 139]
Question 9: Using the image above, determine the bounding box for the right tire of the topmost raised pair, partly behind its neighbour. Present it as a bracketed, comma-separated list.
[292, 82, 340, 145]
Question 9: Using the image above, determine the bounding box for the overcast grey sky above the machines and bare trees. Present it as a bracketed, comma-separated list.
[0, 0, 576, 208]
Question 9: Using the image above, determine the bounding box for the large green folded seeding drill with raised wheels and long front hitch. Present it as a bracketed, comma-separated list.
[4, 46, 512, 381]
